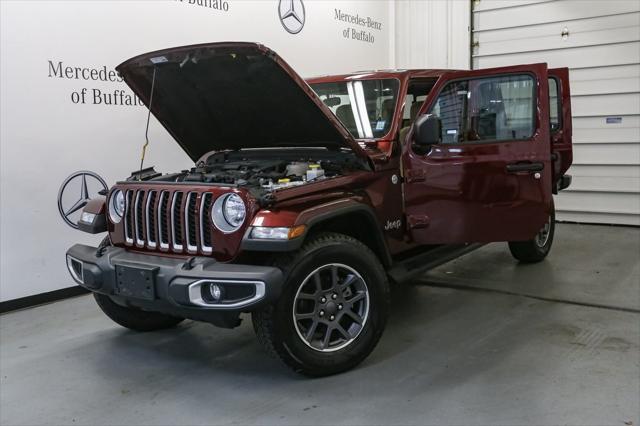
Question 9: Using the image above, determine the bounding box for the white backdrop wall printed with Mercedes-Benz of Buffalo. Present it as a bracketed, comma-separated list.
[0, 0, 393, 301]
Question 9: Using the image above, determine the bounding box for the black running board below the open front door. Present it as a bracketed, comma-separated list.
[388, 244, 484, 282]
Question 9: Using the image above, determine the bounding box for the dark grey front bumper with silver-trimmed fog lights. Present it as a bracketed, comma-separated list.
[67, 244, 283, 327]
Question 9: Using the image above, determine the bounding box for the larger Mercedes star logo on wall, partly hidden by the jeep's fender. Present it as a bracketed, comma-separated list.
[58, 170, 107, 229]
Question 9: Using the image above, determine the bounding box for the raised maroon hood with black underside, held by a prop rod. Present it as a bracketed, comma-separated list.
[116, 42, 366, 161]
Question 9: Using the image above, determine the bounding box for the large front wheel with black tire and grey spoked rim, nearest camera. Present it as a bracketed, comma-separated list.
[252, 233, 389, 377]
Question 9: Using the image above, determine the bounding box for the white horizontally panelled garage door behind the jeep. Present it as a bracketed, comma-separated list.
[472, 0, 640, 225]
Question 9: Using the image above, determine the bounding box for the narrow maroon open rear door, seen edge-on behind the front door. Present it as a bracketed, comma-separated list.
[549, 68, 573, 187]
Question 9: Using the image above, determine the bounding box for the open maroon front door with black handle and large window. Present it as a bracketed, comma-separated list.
[403, 64, 552, 244]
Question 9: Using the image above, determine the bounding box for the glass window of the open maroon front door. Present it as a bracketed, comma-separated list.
[430, 75, 536, 144]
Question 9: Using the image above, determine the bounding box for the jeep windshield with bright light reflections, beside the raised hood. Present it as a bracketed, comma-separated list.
[311, 78, 400, 139]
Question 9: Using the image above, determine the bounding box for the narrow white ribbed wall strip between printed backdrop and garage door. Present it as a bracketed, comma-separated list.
[394, 0, 471, 69]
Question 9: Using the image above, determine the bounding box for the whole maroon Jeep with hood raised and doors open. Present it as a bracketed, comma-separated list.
[66, 43, 572, 376]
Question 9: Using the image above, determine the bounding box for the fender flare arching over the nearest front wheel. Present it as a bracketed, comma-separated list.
[240, 198, 392, 266]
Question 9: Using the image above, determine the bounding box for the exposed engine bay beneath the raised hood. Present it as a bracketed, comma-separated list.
[142, 149, 367, 192]
